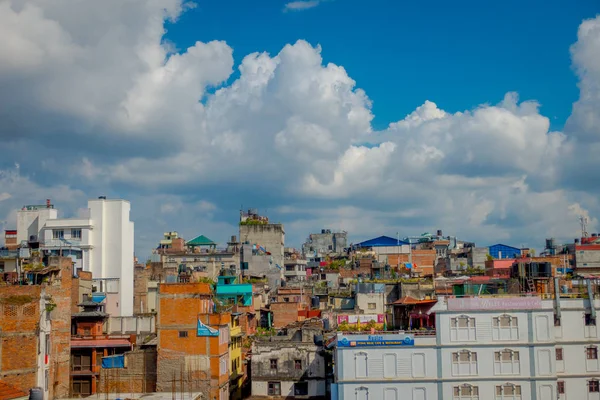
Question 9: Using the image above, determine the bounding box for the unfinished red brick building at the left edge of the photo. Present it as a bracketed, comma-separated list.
[0, 257, 73, 399]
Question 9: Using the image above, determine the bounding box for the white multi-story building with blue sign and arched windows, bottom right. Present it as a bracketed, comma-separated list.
[332, 290, 600, 400]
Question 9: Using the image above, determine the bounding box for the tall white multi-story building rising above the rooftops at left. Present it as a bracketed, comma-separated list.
[17, 197, 134, 316]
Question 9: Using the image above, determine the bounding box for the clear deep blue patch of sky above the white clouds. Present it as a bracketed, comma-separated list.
[166, 0, 600, 129]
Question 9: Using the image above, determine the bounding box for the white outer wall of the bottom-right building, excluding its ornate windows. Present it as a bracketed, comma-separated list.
[335, 299, 600, 400]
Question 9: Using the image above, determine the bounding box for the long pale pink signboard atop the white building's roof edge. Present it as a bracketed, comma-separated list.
[448, 297, 542, 311]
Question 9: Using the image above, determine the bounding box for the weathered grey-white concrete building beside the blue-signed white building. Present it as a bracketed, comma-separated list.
[251, 320, 327, 399]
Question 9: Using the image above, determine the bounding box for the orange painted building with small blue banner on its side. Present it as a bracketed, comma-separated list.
[156, 283, 231, 400]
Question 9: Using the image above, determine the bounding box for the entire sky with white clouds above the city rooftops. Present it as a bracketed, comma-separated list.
[0, 0, 600, 254]
